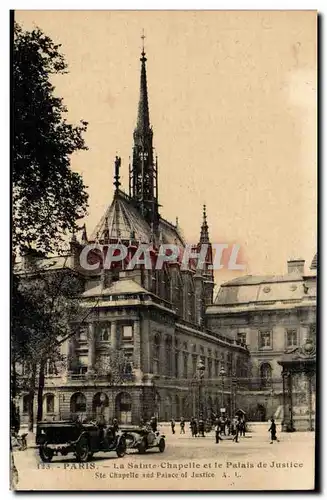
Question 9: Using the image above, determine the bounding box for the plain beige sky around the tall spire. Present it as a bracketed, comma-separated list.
[15, 11, 317, 284]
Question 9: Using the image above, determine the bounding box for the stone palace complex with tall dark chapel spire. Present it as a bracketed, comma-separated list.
[21, 47, 315, 430]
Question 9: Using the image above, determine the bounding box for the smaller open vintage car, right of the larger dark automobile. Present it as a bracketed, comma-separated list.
[120, 426, 166, 453]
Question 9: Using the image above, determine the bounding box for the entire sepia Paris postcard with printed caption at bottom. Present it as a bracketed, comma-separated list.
[10, 11, 318, 491]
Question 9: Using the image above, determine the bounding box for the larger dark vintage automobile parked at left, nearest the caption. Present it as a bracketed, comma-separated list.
[36, 421, 126, 462]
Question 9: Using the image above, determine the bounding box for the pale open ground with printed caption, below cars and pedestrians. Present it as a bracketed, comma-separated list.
[14, 425, 314, 490]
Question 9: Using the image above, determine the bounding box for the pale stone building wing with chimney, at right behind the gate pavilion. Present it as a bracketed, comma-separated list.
[206, 260, 316, 420]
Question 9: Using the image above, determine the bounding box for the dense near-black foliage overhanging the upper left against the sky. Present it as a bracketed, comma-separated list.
[12, 23, 88, 253]
